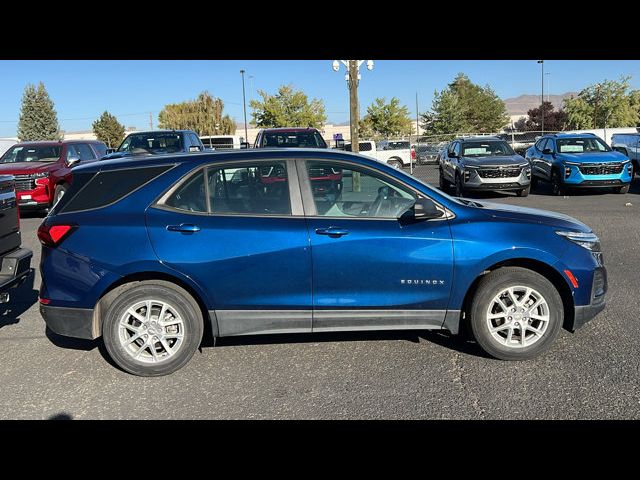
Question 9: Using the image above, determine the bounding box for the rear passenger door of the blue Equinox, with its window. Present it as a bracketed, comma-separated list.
[147, 161, 312, 336]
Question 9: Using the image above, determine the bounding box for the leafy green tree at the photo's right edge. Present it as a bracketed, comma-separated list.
[564, 76, 640, 129]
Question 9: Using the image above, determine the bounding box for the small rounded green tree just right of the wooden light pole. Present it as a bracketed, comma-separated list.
[360, 97, 413, 140]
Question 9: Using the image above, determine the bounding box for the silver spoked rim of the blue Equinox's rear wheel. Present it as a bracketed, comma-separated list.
[118, 300, 185, 364]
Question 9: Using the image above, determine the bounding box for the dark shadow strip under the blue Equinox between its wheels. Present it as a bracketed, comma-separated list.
[202, 330, 490, 358]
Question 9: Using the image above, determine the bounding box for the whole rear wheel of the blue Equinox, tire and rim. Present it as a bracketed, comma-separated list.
[102, 280, 203, 377]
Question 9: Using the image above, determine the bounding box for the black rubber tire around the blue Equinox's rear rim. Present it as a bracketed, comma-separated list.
[102, 280, 204, 377]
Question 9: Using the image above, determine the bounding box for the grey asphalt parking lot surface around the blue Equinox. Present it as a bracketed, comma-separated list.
[0, 166, 640, 419]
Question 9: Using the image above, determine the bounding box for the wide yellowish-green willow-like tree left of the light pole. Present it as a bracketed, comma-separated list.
[158, 91, 236, 135]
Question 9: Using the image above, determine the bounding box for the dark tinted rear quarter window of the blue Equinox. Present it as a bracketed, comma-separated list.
[55, 165, 173, 213]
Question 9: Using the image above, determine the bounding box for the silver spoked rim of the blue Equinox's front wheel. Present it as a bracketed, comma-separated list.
[486, 285, 550, 348]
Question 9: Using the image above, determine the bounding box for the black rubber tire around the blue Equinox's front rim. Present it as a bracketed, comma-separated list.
[469, 267, 564, 360]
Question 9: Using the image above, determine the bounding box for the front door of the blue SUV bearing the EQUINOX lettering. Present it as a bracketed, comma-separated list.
[299, 162, 453, 330]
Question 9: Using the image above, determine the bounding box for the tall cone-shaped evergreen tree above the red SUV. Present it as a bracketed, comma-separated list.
[18, 82, 62, 142]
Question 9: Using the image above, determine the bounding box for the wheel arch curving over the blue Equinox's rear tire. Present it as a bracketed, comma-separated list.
[92, 271, 218, 339]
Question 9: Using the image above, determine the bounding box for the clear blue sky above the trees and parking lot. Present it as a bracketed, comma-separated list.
[0, 58, 640, 137]
